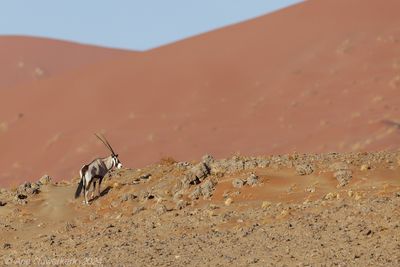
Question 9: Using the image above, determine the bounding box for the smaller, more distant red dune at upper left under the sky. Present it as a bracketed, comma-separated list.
[0, 36, 132, 90]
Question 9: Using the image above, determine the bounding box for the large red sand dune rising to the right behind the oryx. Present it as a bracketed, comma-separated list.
[0, 0, 400, 187]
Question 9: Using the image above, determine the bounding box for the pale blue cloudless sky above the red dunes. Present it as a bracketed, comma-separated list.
[0, 0, 301, 50]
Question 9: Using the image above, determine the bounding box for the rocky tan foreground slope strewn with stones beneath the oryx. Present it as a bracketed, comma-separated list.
[0, 151, 400, 266]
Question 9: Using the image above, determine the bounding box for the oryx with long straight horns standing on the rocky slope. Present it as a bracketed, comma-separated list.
[75, 134, 122, 204]
